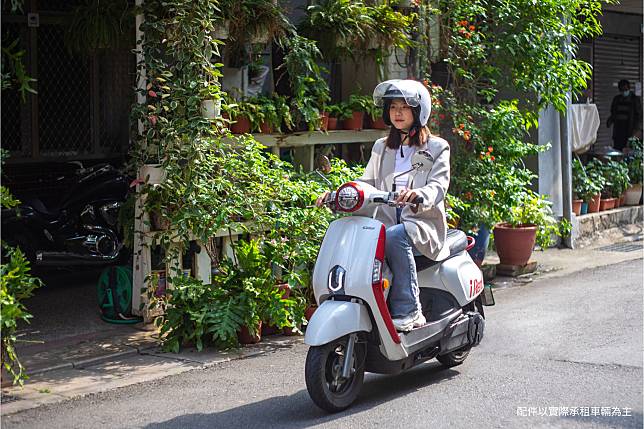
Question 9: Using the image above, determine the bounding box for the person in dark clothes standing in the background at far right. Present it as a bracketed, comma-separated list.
[606, 79, 642, 150]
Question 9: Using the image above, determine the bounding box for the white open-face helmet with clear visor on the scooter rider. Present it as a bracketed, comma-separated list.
[373, 79, 432, 127]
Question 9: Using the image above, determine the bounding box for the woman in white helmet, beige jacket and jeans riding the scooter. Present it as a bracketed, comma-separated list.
[316, 79, 450, 332]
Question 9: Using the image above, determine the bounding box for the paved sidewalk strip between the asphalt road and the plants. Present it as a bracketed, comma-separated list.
[0, 221, 644, 415]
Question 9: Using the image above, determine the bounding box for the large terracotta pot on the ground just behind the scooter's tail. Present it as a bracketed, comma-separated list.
[494, 223, 537, 266]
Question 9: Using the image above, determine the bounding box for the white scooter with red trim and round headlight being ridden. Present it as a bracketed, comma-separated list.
[304, 151, 494, 412]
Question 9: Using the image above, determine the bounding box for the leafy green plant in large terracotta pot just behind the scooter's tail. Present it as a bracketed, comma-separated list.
[494, 190, 566, 266]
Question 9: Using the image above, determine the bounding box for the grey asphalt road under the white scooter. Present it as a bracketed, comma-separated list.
[2, 259, 644, 429]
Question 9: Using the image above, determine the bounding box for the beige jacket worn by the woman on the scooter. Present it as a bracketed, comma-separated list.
[358, 136, 450, 261]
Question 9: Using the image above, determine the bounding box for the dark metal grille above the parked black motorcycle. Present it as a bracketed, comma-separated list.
[1, 8, 136, 162]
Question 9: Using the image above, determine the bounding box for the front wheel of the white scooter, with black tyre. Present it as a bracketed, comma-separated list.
[304, 336, 366, 413]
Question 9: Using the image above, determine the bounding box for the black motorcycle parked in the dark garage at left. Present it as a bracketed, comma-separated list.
[2, 163, 129, 268]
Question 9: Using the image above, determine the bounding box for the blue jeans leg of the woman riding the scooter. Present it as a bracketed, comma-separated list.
[385, 224, 421, 318]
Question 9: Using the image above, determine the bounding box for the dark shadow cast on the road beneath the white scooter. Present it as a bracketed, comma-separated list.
[145, 363, 459, 429]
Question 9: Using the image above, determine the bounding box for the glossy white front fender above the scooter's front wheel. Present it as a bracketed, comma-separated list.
[304, 299, 372, 346]
